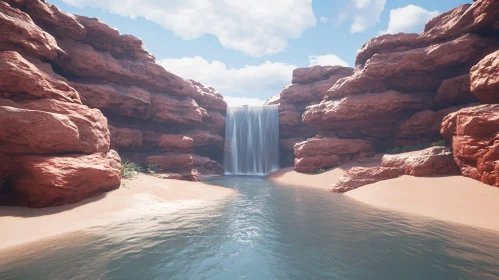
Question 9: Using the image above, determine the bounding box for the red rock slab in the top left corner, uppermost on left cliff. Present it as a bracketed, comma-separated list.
[0, 1, 64, 60]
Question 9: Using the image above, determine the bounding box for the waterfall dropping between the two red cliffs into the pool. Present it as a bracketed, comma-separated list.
[224, 105, 279, 176]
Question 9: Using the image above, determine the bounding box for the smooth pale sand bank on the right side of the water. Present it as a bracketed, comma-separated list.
[267, 156, 499, 231]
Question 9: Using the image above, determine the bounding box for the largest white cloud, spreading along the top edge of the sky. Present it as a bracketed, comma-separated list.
[63, 0, 317, 56]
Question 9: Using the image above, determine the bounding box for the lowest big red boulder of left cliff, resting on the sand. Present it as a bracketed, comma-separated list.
[0, 150, 121, 208]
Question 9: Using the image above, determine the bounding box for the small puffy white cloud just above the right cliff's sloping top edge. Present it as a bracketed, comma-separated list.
[381, 5, 440, 34]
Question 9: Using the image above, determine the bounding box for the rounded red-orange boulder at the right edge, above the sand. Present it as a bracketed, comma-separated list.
[441, 104, 499, 187]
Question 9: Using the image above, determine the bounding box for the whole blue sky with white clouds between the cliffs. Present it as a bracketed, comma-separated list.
[49, 0, 472, 104]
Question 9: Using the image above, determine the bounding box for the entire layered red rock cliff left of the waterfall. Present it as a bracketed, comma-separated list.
[0, 0, 227, 207]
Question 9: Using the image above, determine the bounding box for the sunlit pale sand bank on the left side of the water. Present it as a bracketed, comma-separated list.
[0, 174, 234, 249]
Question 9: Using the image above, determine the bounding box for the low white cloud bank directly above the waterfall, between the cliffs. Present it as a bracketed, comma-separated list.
[158, 56, 297, 99]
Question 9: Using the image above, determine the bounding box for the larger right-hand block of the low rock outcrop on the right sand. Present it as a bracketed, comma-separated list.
[381, 146, 460, 177]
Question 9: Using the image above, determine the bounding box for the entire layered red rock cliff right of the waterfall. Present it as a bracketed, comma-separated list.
[268, 0, 499, 188]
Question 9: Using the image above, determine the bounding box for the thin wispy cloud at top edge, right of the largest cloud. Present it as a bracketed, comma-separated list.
[336, 0, 386, 33]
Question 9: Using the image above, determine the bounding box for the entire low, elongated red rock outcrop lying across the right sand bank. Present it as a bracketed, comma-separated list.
[329, 147, 460, 193]
